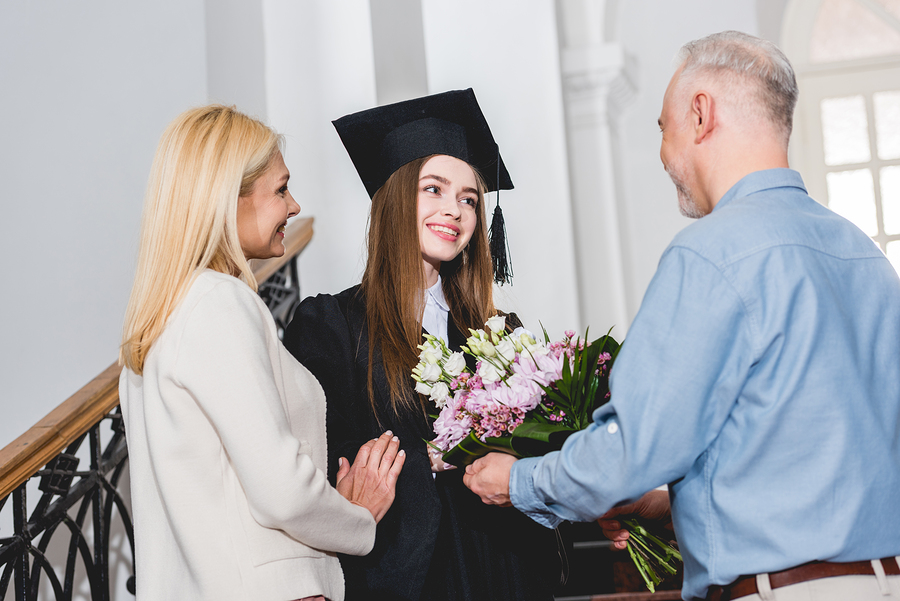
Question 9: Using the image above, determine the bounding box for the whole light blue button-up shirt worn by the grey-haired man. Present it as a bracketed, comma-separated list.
[510, 169, 900, 599]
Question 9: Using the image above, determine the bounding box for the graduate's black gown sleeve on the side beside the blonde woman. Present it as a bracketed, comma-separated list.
[284, 288, 372, 482]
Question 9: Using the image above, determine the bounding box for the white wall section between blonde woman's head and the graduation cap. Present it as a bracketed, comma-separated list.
[263, 0, 375, 296]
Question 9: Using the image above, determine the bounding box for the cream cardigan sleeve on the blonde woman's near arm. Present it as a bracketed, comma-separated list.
[176, 282, 375, 555]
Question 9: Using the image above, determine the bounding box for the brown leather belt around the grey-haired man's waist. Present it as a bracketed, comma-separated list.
[706, 557, 900, 601]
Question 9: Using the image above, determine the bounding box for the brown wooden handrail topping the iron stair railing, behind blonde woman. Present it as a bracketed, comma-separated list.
[0, 217, 313, 499]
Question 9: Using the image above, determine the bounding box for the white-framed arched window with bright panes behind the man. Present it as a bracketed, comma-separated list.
[782, 0, 900, 272]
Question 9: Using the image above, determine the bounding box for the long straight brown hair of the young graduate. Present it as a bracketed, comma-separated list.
[360, 155, 496, 417]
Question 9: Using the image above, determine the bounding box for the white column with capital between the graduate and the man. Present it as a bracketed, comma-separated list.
[557, 0, 634, 338]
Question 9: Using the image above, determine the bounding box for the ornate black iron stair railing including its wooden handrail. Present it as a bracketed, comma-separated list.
[0, 218, 313, 601]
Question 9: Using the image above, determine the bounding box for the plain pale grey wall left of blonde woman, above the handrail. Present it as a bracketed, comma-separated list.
[0, 0, 206, 446]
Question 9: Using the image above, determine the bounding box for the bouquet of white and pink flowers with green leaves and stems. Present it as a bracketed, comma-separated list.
[412, 316, 681, 592]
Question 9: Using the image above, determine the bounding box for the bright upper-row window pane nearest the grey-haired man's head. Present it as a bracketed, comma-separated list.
[821, 96, 872, 165]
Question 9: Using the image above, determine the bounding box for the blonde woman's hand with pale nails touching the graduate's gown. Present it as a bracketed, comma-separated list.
[335, 430, 406, 522]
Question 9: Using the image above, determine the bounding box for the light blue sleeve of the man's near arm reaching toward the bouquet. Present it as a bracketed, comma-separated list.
[510, 247, 755, 526]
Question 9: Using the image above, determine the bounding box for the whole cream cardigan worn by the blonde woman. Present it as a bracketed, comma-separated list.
[119, 270, 375, 601]
